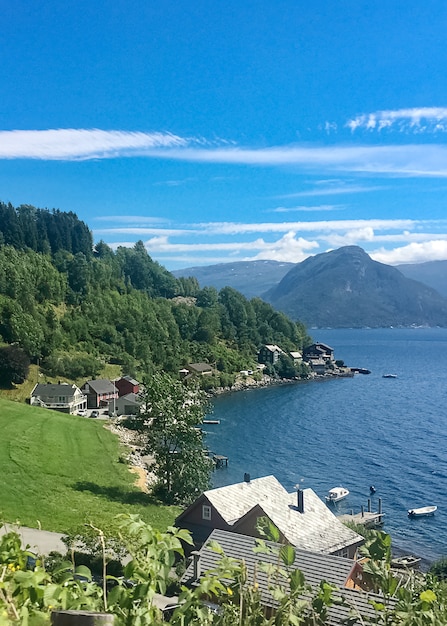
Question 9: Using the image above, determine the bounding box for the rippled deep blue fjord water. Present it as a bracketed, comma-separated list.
[207, 328, 447, 561]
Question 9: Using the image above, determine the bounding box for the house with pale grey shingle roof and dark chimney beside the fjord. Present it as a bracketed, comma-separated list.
[176, 475, 364, 558]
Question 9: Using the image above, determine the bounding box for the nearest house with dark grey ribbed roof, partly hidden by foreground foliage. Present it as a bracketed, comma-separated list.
[181, 530, 384, 626]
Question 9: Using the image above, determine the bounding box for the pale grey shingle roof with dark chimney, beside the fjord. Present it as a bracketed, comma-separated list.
[204, 476, 363, 553]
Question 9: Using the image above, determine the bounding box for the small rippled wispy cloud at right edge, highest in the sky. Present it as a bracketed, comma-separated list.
[346, 107, 447, 133]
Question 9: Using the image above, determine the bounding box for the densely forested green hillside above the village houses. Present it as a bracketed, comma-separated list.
[0, 203, 309, 384]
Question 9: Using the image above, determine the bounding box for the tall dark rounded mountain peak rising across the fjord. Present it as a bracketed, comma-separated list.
[263, 246, 447, 328]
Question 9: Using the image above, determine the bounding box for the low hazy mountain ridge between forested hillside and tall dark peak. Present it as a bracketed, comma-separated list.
[172, 261, 295, 298]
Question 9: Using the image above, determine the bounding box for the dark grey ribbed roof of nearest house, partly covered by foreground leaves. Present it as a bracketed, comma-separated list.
[182, 530, 394, 626]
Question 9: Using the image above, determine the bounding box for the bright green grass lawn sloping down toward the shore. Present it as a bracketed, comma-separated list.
[0, 399, 180, 533]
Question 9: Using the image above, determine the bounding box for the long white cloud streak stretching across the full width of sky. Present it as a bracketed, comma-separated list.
[4, 129, 447, 177]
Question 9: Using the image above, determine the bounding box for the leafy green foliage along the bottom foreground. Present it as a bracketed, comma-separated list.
[0, 515, 447, 626]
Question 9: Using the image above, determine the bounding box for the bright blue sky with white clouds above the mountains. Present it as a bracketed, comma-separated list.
[0, 0, 447, 269]
